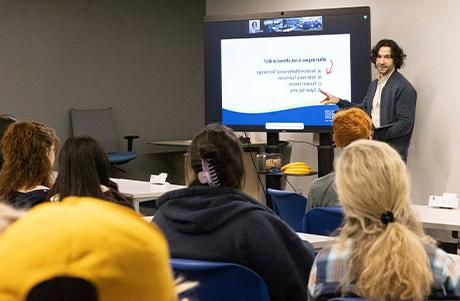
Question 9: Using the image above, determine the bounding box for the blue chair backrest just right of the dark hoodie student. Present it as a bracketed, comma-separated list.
[267, 188, 307, 232]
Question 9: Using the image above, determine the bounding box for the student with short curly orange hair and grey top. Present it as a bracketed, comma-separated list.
[307, 108, 372, 210]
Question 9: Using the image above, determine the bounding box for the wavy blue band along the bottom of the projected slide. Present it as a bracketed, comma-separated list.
[222, 105, 338, 126]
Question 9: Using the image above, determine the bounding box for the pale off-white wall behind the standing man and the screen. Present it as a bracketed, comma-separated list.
[206, 0, 460, 203]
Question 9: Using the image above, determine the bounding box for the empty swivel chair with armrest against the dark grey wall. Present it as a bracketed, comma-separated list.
[70, 108, 139, 171]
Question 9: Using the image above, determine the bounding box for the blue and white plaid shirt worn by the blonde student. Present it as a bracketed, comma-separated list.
[308, 241, 460, 300]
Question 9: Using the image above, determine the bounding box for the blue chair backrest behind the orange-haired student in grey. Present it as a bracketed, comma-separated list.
[303, 207, 343, 235]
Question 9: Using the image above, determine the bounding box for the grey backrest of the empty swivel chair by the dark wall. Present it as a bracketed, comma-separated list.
[70, 108, 120, 153]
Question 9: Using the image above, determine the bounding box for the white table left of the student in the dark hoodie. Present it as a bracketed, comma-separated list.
[111, 178, 187, 212]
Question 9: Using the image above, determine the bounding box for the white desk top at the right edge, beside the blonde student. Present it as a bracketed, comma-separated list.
[412, 205, 460, 231]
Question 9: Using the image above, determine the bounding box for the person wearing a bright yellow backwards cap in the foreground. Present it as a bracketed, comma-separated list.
[0, 197, 177, 301]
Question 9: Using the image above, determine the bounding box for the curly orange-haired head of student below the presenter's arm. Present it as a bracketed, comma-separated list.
[332, 108, 372, 147]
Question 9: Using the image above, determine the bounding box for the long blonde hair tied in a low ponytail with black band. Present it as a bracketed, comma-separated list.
[336, 140, 433, 300]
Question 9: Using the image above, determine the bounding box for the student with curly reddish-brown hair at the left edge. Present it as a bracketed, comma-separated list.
[0, 122, 59, 208]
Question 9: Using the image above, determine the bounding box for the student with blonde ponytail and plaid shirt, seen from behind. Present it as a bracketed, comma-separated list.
[309, 140, 460, 300]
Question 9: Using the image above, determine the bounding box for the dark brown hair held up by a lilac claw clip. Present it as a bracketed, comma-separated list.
[188, 123, 244, 189]
